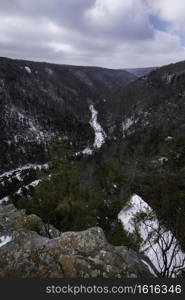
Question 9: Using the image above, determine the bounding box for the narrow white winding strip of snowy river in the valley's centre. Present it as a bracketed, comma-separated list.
[89, 105, 106, 148]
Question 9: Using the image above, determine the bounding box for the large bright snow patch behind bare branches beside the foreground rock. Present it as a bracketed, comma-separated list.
[118, 195, 185, 277]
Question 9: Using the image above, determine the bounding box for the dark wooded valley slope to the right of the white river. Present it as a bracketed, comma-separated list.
[107, 62, 185, 258]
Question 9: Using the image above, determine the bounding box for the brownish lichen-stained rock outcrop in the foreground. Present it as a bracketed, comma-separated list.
[0, 204, 152, 278]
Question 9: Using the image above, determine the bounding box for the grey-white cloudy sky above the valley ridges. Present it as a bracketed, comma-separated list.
[0, 0, 185, 68]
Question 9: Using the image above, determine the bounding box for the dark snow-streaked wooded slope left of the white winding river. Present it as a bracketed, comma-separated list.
[0, 58, 135, 170]
